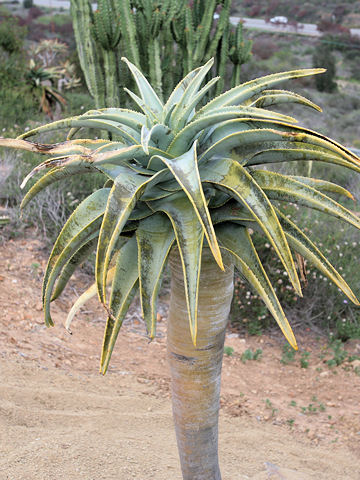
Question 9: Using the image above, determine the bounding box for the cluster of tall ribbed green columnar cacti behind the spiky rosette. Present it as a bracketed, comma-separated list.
[71, 0, 251, 108]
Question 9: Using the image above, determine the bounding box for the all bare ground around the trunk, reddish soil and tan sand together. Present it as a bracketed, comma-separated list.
[0, 232, 360, 480]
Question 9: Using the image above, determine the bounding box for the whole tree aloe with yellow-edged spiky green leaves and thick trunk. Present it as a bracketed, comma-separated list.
[0, 59, 360, 480]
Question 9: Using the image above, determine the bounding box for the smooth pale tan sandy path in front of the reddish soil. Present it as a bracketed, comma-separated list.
[0, 358, 359, 480]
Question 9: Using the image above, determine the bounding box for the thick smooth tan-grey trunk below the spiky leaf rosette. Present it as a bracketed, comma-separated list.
[167, 248, 233, 480]
